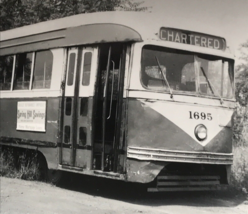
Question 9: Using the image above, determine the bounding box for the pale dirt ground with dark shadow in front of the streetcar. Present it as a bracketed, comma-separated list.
[0, 177, 248, 214]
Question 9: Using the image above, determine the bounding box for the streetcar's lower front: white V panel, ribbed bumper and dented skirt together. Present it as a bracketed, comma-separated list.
[127, 98, 233, 182]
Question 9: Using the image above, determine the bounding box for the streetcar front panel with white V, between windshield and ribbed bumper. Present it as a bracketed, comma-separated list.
[127, 99, 232, 153]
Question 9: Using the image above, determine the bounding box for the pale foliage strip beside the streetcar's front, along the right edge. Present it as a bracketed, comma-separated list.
[231, 40, 248, 193]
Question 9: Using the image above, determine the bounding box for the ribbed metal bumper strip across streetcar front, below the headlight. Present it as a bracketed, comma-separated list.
[127, 147, 233, 165]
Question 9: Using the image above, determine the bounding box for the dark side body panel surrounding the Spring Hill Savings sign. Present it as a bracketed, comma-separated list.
[0, 97, 61, 146]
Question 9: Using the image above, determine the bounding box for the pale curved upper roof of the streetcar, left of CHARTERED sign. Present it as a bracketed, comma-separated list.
[0, 11, 234, 58]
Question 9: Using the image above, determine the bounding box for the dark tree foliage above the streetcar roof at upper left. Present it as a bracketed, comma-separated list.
[0, 0, 148, 31]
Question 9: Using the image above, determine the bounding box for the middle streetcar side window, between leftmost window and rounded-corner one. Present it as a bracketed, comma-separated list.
[13, 53, 33, 90]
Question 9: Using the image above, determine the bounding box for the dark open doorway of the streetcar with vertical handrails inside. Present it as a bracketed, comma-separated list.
[93, 44, 123, 171]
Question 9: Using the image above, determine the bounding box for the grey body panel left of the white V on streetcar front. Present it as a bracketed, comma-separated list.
[127, 99, 203, 151]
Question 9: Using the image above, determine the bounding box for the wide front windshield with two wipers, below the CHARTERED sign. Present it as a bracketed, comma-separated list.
[141, 45, 233, 99]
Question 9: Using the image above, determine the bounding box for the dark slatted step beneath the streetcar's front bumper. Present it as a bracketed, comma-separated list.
[148, 175, 227, 192]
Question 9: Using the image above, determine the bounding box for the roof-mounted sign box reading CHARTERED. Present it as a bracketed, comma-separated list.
[160, 27, 226, 50]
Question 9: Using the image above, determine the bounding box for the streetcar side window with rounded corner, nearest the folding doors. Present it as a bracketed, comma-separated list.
[32, 50, 53, 89]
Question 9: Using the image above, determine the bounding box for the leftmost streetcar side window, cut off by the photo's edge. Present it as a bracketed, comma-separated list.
[0, 56, 14, 91]
